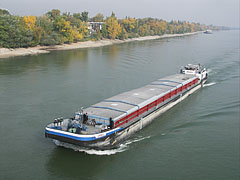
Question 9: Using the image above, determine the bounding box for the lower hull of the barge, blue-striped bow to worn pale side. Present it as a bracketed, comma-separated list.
[45, 79, 207, 150]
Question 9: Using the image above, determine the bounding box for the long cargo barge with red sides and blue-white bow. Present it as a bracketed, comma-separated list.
[45, 64, 207, 150]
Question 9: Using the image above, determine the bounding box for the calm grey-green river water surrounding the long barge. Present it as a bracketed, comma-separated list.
[0, 31, 240, 180]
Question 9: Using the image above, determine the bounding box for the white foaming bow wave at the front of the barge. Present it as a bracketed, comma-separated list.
[53, 136, 151, 156]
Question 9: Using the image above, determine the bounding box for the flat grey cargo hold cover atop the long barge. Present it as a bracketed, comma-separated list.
[84, 74, 196, 123]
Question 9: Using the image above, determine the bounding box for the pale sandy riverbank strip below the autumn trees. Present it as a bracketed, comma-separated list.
[0, 32, 200, 58]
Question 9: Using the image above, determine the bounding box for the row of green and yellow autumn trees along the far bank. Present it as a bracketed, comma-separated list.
[0, 9, 219, 48]
